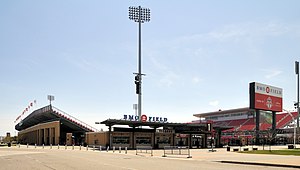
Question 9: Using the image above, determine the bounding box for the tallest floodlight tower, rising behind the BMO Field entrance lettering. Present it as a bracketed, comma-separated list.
[129, 6, 150, 120]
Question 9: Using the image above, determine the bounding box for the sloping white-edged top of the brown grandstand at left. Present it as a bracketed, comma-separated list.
[15, 105, 97, 132]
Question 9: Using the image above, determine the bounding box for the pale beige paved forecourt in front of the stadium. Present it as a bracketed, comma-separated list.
[0, 145, 300, 170]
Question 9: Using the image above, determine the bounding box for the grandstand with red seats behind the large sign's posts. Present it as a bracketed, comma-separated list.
[191, 107, 297, 145]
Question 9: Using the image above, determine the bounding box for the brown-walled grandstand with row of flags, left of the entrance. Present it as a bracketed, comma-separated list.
[15, 105, 98, 145]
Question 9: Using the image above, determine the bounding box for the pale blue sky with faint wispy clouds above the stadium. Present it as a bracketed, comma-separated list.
[0, 0, 300, 135]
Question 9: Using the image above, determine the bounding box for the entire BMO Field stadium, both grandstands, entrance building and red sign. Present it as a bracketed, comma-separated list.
[15, 82, 299, 148]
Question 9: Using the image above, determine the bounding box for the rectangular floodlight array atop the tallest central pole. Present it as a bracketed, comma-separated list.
[128, 6, 150, 23]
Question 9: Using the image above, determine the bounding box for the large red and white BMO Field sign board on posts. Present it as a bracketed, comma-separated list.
[250, 82, 282, 112]
